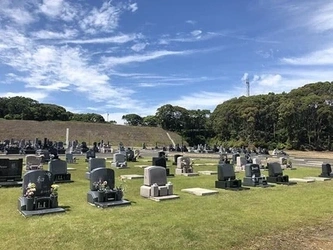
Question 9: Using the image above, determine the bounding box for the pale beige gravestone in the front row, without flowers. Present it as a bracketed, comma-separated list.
[140, 166, 179, 201]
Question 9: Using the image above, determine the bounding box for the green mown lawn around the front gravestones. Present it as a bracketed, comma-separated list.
[0, 158, 333, 250]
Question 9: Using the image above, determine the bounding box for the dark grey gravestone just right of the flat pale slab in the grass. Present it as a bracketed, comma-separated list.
[215, 163, 248, 190]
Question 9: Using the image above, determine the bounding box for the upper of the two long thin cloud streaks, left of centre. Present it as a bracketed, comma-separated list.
[59, 34, 138, 44]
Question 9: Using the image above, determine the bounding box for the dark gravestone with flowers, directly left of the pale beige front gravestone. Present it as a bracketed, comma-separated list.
[87, 167, 131, 208]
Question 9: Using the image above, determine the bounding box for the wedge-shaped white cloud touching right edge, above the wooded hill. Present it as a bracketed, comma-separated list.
[281, 47, 333, 65]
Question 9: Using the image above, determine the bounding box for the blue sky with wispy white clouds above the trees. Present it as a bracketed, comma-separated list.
[0, 0, 333, 124]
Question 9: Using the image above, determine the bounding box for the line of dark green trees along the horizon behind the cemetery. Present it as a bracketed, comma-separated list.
[0, 82, 333, 150]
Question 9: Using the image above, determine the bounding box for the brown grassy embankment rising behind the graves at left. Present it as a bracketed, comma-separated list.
[0, 120, 181, 147]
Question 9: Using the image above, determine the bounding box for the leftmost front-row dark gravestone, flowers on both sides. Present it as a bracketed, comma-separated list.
[18, 170, 65, 217]
